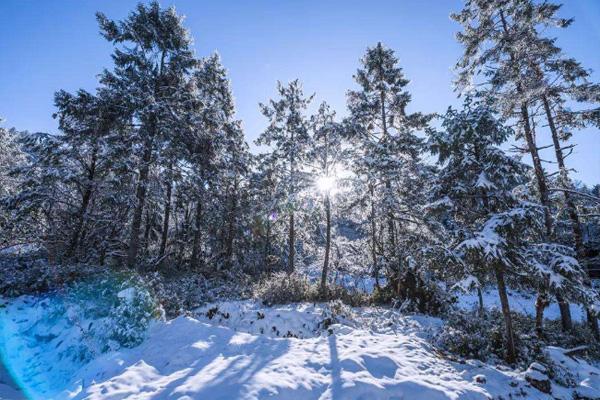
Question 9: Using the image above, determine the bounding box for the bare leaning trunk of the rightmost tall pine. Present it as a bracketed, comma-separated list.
[542, 95, 600, 339]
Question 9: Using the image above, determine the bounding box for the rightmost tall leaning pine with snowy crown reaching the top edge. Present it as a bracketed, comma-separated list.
[496, 0, 600, 338]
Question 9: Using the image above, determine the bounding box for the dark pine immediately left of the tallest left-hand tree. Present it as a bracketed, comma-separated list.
[55, 90, 128, 259]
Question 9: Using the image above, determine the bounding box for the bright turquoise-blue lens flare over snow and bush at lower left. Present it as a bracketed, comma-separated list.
[0, 272, 160, 400]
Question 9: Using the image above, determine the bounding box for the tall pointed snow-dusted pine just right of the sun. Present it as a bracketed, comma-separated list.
[347, 43, 430, 294]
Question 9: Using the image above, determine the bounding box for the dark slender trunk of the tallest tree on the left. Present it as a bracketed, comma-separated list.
[127, 139, 152, 268]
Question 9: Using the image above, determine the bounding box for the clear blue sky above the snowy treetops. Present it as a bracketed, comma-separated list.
[0, 0, 600, 184]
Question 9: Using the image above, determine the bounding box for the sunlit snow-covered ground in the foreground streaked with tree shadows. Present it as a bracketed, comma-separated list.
[0, 298, 600, 400]
